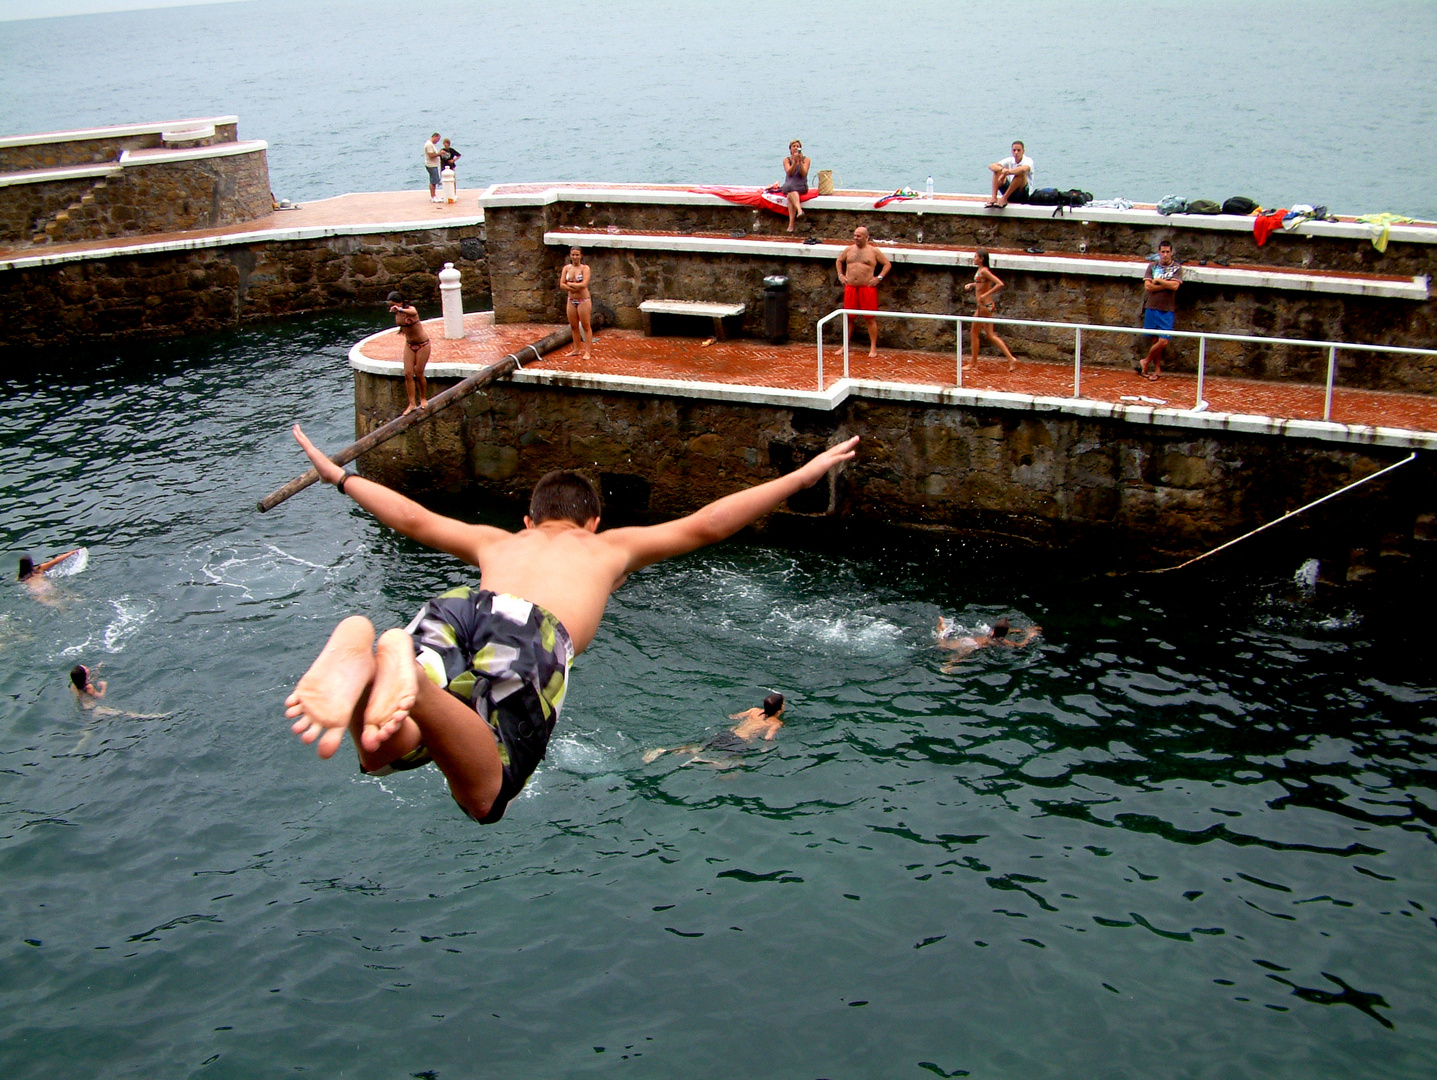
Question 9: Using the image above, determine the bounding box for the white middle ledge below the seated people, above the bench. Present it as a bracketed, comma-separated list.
[546, 225, 1428, 300]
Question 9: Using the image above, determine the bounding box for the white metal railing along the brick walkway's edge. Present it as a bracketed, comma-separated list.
[818, 307, 1437, 421]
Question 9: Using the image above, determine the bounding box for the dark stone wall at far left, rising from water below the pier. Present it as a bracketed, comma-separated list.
[0, 225, 489, 354]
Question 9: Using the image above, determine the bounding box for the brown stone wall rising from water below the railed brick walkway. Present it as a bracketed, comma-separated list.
[355, 372, 1437, 566]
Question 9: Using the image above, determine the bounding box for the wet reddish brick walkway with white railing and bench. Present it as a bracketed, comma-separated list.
[353, 312, 1437, 431]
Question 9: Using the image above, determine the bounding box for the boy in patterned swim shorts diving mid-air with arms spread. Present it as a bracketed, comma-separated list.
[285, 424, 858, 824]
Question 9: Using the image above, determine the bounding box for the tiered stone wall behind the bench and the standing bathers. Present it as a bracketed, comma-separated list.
[486, 201, 1437, 394]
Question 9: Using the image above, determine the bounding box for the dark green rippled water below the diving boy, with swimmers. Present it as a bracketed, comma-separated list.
[0, 311, 1437, 1080]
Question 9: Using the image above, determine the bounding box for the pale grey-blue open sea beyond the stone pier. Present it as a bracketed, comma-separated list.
[0, 0, 1437, 218]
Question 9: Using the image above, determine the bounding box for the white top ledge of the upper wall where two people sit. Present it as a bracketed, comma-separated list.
[479, 184, 1437, 252]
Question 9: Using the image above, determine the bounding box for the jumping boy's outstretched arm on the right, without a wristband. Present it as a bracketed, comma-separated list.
[599, 435, 858, 573]
